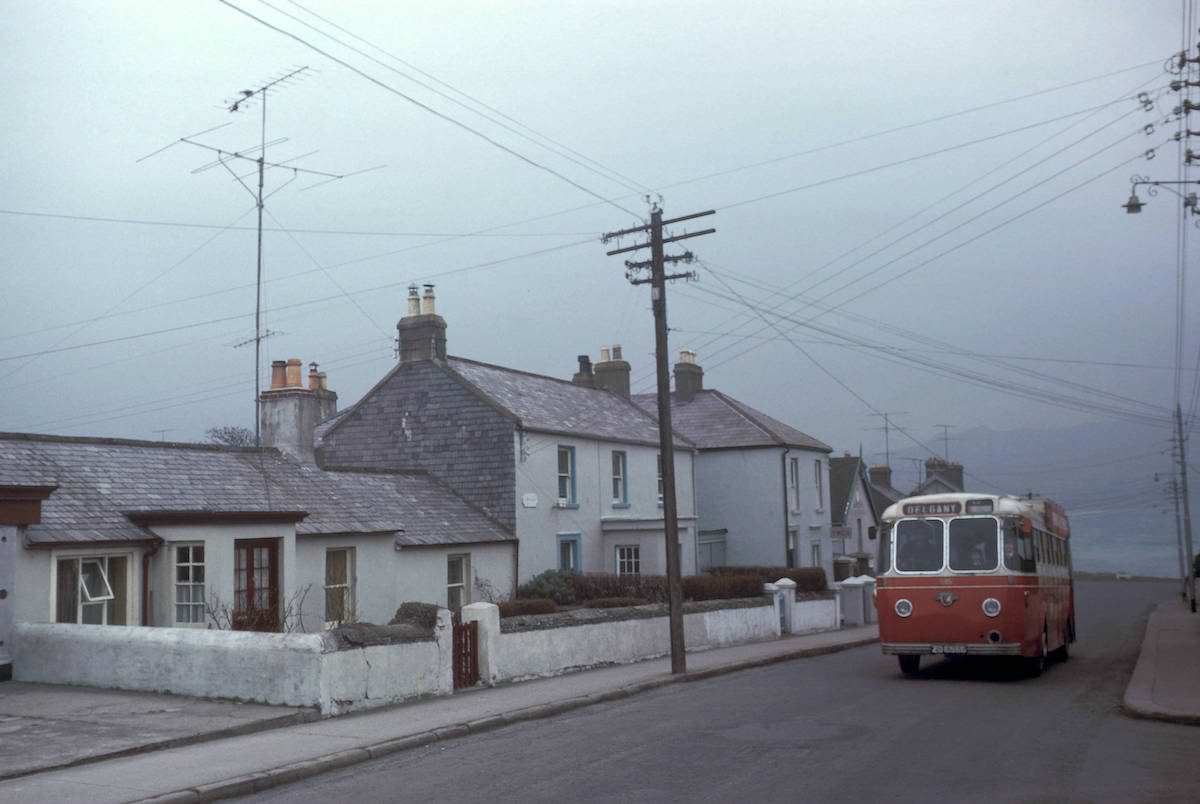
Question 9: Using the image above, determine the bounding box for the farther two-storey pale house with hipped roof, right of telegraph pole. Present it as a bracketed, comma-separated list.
[634, 349, 833, 578]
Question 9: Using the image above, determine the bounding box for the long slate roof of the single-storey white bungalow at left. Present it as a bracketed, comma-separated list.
[0, 433, 512, 546]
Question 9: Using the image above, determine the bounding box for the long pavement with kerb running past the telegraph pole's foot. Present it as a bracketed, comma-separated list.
[0, 626, 878, 803]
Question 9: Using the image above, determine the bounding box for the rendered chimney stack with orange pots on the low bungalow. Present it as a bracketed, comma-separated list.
[258, 358, 337, 463]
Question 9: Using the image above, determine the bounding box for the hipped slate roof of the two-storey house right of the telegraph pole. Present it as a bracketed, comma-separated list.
[634, 389, 833, 452]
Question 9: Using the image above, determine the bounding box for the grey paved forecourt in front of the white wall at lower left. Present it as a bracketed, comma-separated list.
[0, 682, 318, 780]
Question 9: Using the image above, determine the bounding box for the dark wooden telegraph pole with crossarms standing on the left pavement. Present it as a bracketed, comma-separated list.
[601, 204, 716, 674]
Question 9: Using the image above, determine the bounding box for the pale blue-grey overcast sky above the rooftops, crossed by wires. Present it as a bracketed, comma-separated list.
[0, 0, 1200, 496]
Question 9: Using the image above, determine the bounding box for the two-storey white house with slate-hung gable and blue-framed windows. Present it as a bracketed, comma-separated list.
[314, 286, 696, 594]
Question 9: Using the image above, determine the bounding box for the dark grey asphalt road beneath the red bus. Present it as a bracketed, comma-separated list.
[248, 582, 1200, 804]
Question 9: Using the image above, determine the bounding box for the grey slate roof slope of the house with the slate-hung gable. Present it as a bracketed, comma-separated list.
[446, 358, 691, 448]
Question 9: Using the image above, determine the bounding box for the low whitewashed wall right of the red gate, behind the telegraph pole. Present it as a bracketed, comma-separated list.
[463, 598, 780, 683]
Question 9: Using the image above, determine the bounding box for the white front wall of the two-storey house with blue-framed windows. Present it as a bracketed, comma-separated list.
[514, 432, 696, 582]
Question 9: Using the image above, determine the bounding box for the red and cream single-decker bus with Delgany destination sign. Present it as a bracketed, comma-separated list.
[875, 493, 1075, 676]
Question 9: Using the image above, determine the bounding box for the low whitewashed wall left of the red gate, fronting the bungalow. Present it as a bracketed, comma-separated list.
[13, 610, 454, 715]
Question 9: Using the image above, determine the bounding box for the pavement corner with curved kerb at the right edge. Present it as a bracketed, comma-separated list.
[1123, 598, 1200, 726]
